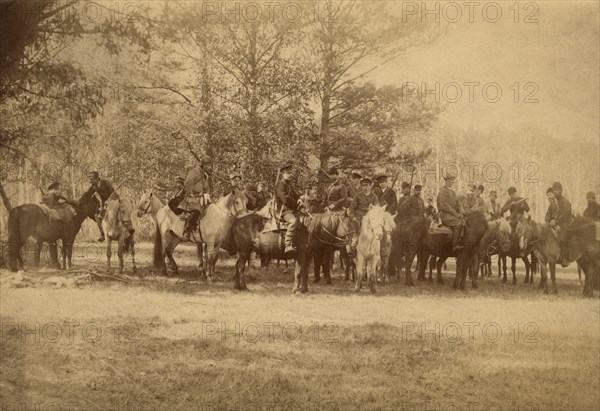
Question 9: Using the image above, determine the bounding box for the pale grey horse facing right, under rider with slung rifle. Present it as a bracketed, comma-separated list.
[154, 189, 247, 281]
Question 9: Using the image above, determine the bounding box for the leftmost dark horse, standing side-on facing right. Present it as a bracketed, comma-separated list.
[8, 197, 100, 272]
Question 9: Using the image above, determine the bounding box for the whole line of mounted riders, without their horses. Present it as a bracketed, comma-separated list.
[35, 156, 600, 278]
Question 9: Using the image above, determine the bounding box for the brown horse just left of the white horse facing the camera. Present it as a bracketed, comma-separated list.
[309, 211, 354, 284]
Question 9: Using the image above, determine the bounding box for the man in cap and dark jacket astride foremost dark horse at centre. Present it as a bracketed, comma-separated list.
[275, 164, 299, 254]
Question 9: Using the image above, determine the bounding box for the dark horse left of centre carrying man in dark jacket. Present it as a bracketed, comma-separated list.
[233, 213, 312, 293]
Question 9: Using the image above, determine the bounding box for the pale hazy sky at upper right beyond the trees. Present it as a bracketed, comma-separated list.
[370, 1, 600, 142]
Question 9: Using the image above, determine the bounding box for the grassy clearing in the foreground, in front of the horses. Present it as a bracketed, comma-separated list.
[0, 244, 600, 410]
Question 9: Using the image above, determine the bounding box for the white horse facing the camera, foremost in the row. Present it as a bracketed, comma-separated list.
[354, 204, 389, 293]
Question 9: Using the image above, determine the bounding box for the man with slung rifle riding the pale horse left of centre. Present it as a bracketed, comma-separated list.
[180, 156, 212, 241]
